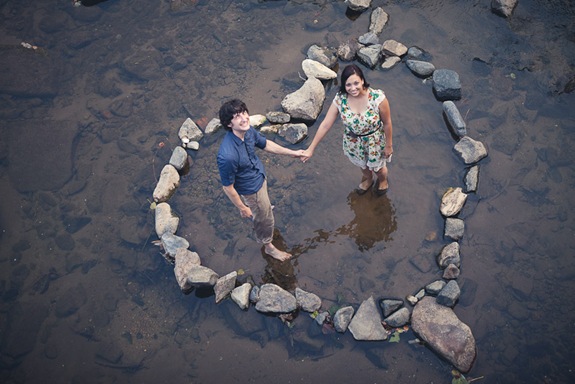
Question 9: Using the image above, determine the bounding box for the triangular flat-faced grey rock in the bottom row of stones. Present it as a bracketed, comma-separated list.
[348, 296, 388, 340]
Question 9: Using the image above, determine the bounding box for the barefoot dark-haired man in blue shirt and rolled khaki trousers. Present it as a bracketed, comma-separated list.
[218, 99, 303, 261]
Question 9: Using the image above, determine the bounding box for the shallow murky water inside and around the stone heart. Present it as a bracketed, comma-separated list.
[0, 0, 575, 383]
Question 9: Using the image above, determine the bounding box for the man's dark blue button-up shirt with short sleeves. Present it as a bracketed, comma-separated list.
[218, 127, 266, 195]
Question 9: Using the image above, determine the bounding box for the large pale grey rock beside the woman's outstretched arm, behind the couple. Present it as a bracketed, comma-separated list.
[281, 77, 325, 121]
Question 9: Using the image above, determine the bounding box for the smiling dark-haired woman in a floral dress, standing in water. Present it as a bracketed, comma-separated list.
[302, 64, 393, 196]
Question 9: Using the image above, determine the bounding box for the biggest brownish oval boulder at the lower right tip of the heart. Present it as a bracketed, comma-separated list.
[411, 297, 476, 373]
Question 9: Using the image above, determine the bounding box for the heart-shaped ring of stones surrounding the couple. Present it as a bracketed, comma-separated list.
[152, 2, 487, 373]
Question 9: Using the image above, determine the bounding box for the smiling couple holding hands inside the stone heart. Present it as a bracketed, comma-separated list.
[217, 64, 393, 261]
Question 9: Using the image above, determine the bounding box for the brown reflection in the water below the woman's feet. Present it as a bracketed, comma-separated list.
[291, 192, 397, 256]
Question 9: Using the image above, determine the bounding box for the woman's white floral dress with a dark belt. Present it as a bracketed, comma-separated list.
[333, 88, 385, 172]
